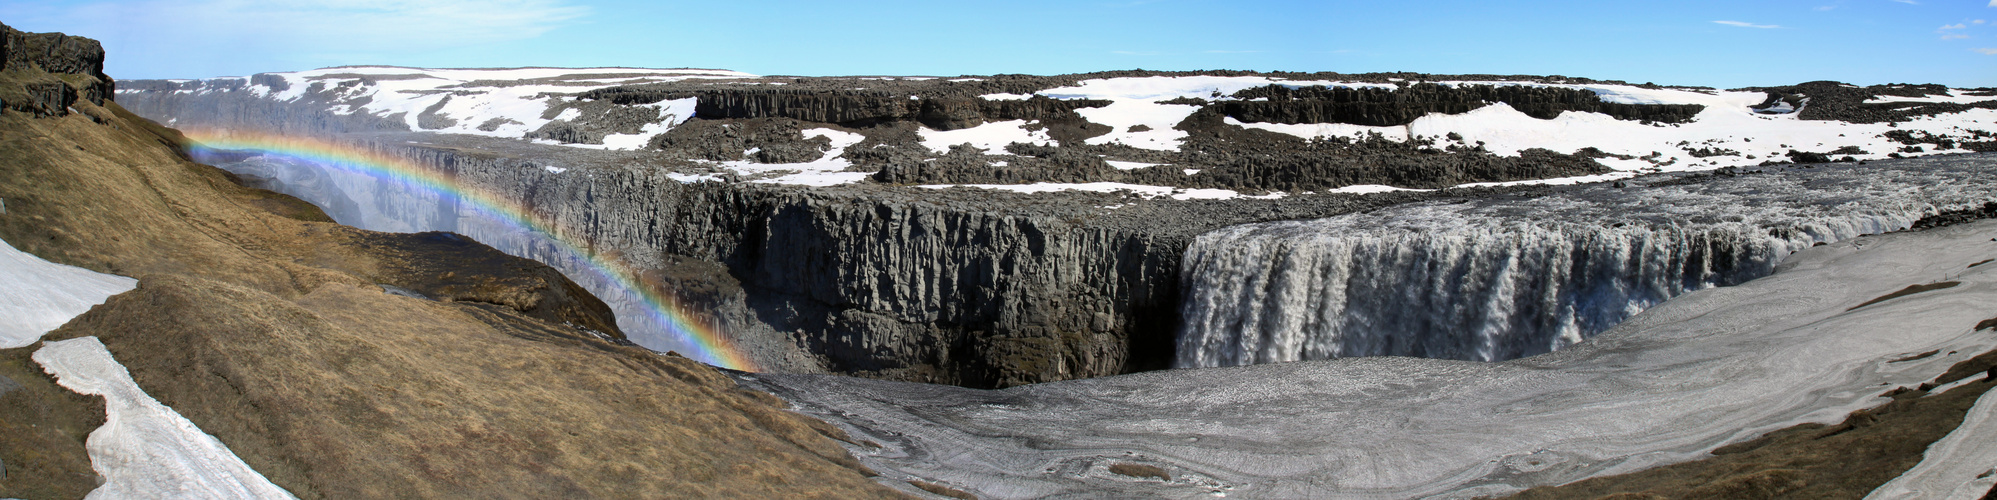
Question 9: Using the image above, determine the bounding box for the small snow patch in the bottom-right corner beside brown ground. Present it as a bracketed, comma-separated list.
[1865, 384, 1997, 500]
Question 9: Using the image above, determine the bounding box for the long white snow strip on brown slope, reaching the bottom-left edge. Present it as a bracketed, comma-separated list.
[32, 336, 296, 498]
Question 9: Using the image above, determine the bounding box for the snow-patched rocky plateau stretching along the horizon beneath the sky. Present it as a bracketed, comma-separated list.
[118, 66, 1997, 198]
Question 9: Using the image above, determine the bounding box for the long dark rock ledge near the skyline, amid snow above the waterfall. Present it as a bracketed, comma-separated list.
[1214, 84, 1705, 126]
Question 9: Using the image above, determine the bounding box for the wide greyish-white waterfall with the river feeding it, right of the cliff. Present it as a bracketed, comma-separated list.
[1174, 163, 1991, 368]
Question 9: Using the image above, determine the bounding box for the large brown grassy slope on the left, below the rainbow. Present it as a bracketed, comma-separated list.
[0, 76, 895, 498]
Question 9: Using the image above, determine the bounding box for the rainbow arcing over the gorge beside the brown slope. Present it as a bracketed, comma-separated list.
[182, 128, 757, 372]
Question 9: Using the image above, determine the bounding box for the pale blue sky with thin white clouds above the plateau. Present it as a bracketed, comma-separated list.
[0, 0, 1997, 88]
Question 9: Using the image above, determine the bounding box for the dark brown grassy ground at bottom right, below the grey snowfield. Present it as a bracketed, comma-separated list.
[1512, 344, 1997, 500]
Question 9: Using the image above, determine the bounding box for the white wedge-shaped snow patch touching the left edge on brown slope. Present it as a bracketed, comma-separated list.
[0, 242, 138, 348]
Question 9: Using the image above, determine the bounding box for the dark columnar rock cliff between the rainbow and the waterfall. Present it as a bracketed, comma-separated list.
[273, 136, 1453, 386]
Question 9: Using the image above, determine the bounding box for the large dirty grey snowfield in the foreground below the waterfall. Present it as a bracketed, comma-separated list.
[757, 222, 1997, 498]
